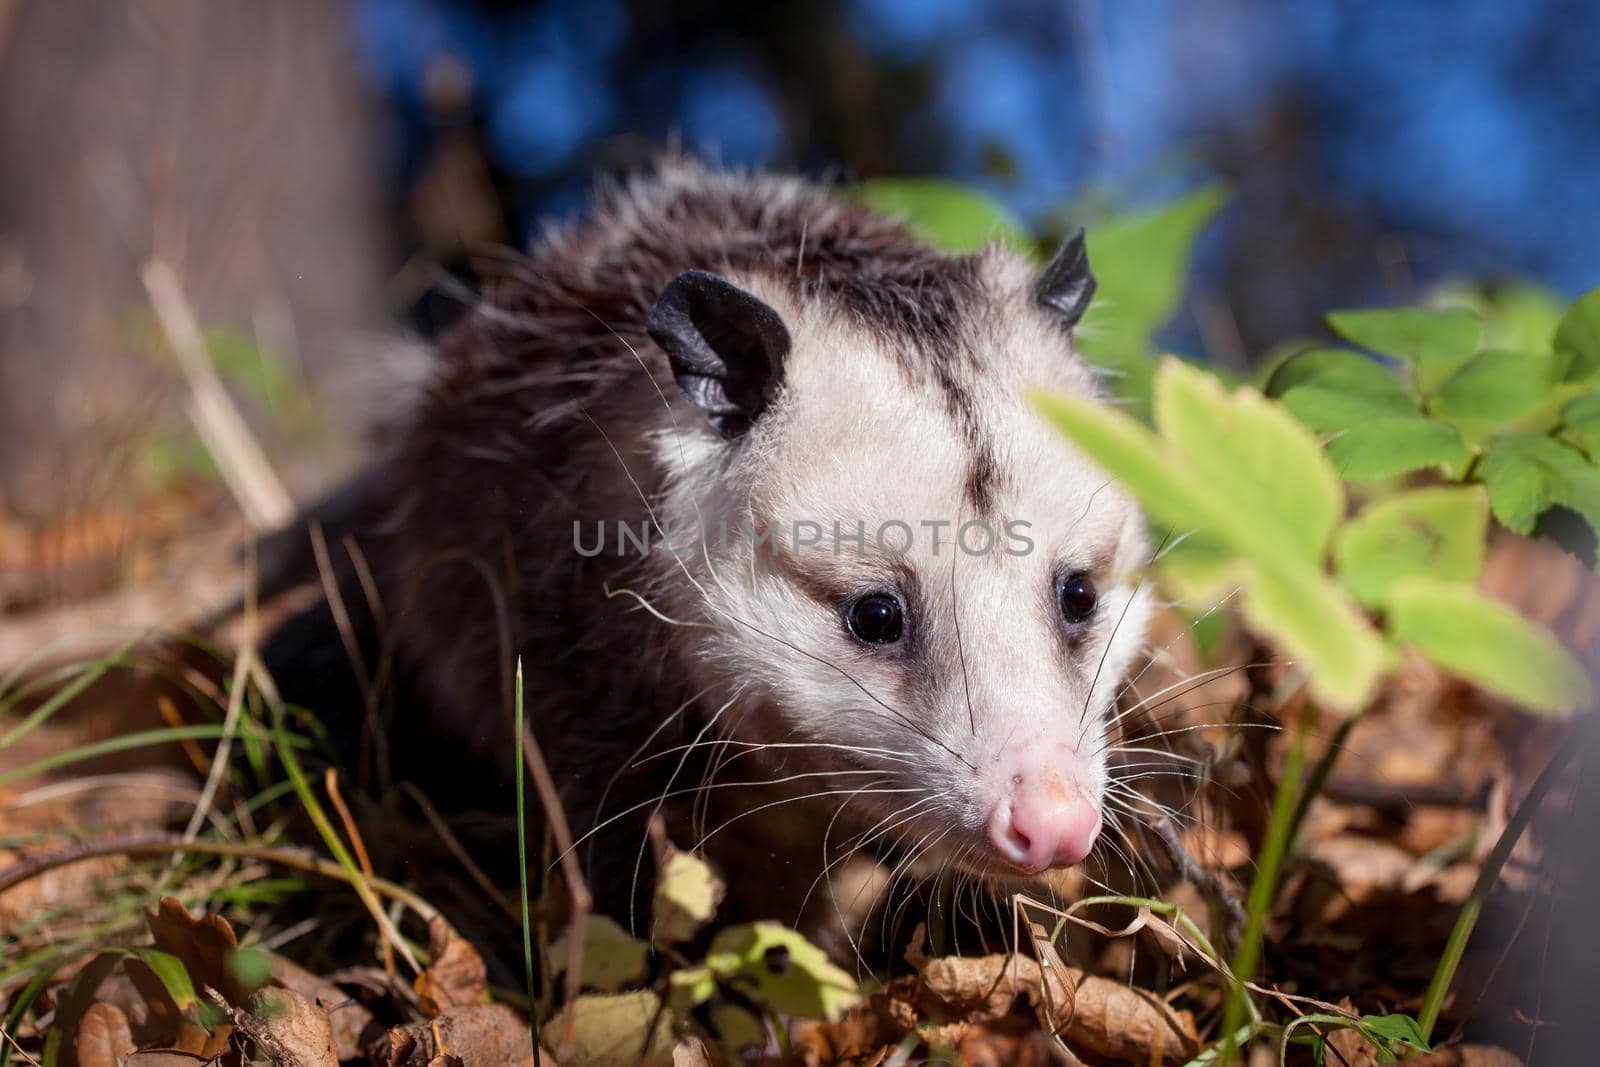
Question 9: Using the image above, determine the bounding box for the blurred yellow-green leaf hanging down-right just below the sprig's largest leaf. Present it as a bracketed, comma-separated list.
[1245, 561, 1389, 712]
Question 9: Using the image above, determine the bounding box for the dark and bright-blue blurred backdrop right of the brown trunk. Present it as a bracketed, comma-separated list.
[352, 0, 1600, 356]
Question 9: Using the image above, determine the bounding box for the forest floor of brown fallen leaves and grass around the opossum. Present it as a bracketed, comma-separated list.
[0, 491, 1597, 1067]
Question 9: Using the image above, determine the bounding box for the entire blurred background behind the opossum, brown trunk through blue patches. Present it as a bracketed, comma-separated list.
[0, 0, 1600, 530]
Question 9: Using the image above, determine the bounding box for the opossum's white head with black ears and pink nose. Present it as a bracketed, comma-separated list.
[650, 231, 1149, 873]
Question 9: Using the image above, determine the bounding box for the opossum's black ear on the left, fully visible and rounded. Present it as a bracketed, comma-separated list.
[648, 270, 789, 440]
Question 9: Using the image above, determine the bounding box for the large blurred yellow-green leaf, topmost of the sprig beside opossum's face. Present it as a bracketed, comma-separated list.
[1155, 360, 1344, 566]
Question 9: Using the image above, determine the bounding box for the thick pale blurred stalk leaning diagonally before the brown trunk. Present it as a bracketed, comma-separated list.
[139, 259, 294, 530]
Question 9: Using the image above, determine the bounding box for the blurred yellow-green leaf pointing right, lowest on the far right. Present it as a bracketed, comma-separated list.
[1389, 577, 1589, 715]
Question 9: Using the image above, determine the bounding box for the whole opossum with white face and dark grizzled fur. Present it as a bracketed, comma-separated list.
[266, 158, 1150, 940]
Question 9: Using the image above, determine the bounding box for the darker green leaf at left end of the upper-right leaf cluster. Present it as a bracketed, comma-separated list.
[1266, 349, 1418, 430]
